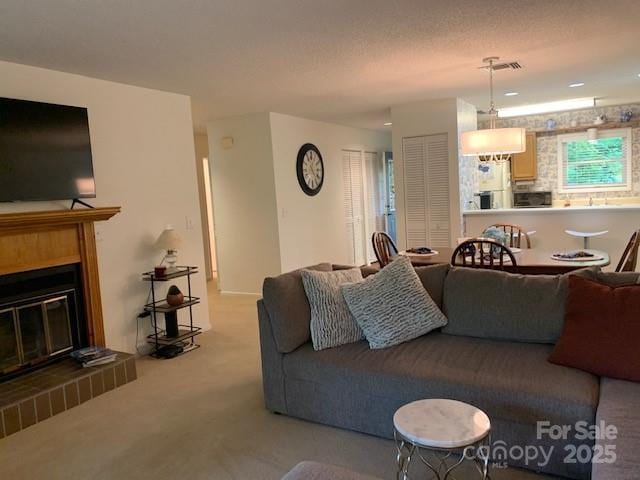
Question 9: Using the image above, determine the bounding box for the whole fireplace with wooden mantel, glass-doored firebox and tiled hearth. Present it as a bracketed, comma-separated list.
[0, 207, 136, 438]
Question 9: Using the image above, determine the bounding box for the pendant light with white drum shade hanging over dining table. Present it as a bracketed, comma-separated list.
[461, 57, 526, 162]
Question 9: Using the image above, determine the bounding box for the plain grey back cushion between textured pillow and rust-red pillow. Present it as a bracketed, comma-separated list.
[443, 267, 592, 344]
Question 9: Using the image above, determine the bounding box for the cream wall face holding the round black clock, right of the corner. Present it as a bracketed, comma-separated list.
[271, 113, 391, 272]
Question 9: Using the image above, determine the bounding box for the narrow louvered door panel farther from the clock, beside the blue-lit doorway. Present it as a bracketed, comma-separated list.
[364, 152, 385, 262]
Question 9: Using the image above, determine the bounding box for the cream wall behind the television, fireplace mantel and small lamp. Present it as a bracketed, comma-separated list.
[0, 62, 209, 352]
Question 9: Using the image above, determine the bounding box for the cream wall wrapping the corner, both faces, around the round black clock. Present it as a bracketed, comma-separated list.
[207, 113, 390, 293]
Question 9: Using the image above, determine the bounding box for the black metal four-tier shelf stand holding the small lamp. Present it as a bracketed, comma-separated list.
[142, 266, 202, 358]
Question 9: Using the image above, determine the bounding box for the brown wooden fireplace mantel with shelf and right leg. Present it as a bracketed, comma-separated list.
[0, 207, 120, 346]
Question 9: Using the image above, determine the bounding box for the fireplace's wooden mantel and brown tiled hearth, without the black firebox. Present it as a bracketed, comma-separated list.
[0, 207, 136, 438]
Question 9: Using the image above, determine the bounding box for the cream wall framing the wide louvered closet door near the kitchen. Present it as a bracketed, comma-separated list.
[391, 98, 468, 249]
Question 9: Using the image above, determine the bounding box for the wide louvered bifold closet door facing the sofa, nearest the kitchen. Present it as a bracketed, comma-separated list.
[402, 134, 451, 248]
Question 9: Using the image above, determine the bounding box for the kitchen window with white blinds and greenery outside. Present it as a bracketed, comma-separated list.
[558, 128, 631, 193]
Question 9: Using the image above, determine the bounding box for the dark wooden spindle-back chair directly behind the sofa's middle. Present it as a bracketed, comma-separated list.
[451, 237, 517, 270]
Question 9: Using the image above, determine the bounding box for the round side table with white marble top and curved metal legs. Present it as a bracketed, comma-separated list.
[393, 399, 491, 480]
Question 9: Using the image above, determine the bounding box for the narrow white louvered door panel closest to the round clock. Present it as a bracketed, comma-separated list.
[342, 150, 366, 265]
